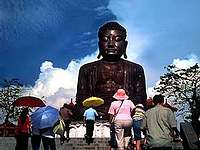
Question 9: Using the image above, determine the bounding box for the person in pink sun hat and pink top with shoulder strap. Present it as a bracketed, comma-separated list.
[108, 89, 135, 150]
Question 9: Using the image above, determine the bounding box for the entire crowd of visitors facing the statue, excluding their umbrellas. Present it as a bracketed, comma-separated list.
[15, 89, 179, 150]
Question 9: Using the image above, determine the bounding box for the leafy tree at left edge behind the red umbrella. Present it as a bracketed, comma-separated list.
[0, 79, 24, 122]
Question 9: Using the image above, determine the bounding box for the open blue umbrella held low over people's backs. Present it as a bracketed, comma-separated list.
[31, 106, 59, 129]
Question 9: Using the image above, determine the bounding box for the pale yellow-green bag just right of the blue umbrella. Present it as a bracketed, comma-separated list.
[53, 119, 65, 135]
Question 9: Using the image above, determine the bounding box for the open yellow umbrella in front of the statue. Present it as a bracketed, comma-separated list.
[83, 96, 104, 107]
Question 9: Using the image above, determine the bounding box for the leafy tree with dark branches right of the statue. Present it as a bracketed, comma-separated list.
[155, 64, 200, 132]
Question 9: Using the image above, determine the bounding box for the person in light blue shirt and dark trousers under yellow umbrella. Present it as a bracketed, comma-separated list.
[83, 106, 98, 144]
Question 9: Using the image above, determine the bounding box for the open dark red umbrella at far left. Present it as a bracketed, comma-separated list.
[13, 96, 45, 107]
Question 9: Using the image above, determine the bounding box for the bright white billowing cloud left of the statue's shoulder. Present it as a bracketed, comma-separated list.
[29, 51, 97, 107]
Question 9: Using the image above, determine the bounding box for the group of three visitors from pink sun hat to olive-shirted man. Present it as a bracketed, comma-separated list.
[108, 89, 179, 150]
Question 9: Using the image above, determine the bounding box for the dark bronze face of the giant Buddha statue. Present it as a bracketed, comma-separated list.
[99, 30, 128, 61]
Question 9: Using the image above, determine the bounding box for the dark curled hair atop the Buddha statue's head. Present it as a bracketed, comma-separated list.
[98, 21, 127, 39]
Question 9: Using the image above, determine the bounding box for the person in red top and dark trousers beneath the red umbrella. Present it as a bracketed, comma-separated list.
[15, 108, 31, 150]
